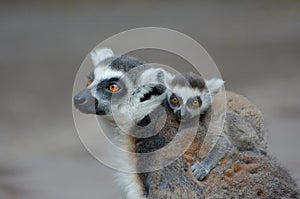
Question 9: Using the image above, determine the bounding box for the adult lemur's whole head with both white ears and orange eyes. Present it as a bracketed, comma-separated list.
[73, 49, 167, 120]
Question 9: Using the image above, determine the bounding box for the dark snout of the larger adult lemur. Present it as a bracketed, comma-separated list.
[73, 89, 97, 113]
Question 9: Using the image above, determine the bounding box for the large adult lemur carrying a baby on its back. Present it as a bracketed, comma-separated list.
[74, 49, 296, 199]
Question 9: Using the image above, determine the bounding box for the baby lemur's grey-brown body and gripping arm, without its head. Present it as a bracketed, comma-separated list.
[191, 92, 267, 180]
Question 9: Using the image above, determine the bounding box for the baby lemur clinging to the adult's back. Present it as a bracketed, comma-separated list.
[167, 72, 267, 180]
